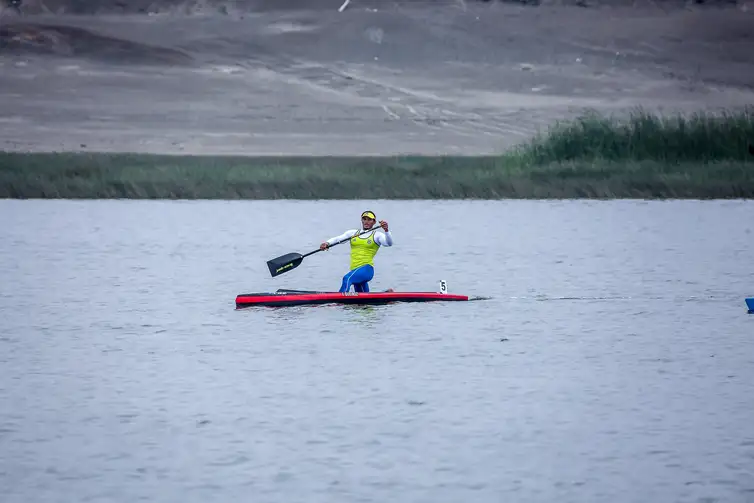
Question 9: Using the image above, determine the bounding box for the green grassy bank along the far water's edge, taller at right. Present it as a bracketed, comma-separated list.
[0, 109, 754, 199]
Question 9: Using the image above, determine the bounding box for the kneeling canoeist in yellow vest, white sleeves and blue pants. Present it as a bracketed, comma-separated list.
[319, 211, 393, 292]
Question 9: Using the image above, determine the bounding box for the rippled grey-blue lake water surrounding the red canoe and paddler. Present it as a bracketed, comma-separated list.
[0, 201, 754, 503]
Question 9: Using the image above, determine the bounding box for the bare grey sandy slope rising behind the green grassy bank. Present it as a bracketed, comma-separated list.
[0, 0, 754, 154]
